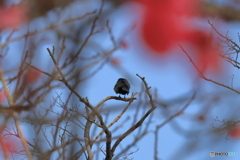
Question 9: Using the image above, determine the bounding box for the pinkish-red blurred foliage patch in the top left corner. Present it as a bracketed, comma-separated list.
[0, 5, 27, 30]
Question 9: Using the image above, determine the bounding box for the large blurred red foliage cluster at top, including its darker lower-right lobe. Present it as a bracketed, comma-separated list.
[131, 0, 220, 72]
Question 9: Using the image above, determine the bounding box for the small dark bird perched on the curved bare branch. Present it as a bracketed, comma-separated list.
[114, 78, 130, 97]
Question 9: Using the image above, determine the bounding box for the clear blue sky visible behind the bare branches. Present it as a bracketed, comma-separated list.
[0, 0, 240, 160]
